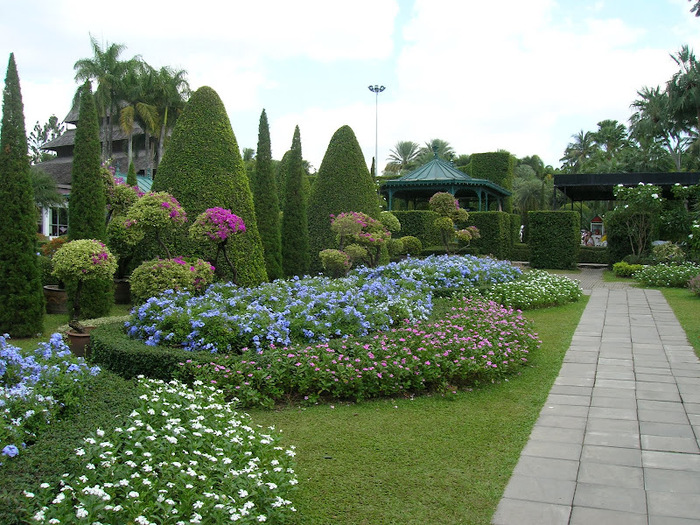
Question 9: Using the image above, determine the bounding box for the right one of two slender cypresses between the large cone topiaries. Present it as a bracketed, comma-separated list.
[282, 126, 310, 277]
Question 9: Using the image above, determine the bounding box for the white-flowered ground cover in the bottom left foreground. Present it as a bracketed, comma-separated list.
[25, 378, 297, 525]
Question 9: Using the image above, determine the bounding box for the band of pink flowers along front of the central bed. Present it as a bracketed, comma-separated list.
[181, 298, 540, 406]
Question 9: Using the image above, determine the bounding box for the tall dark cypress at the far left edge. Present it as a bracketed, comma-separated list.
[0, 53, 44, 337]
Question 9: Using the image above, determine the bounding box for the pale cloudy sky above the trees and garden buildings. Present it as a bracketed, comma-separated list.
[0, 0, 700, 170]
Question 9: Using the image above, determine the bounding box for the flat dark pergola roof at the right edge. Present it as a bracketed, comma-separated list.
[554, 172, 700, 204]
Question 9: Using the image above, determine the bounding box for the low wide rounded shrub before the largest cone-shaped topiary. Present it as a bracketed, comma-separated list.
[129, 257, 214, 304]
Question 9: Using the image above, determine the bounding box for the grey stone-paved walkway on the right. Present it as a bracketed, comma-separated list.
[492, 270, 700, 525]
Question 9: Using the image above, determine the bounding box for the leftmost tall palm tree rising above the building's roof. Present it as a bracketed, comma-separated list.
[73, 36, 137, 160]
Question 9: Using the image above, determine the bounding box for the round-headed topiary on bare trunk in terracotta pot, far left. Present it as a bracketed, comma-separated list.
[52, 239, 117, 355]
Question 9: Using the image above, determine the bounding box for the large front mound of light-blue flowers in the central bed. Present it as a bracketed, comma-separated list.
[126, 274, 432, 352]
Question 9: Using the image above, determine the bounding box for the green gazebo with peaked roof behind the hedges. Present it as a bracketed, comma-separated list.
[379, 153, 511, 211]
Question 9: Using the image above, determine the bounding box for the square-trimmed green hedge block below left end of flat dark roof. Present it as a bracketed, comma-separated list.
[528, 211, 581, 270]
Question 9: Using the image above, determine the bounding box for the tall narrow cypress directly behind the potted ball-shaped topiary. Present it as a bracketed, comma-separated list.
[66, 81, 114, 318]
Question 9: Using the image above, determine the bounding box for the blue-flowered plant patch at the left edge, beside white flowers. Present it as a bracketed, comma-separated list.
[0, 333, 100, 460]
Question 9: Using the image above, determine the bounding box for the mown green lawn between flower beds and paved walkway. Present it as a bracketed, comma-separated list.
[250, 298, 587, 525]
